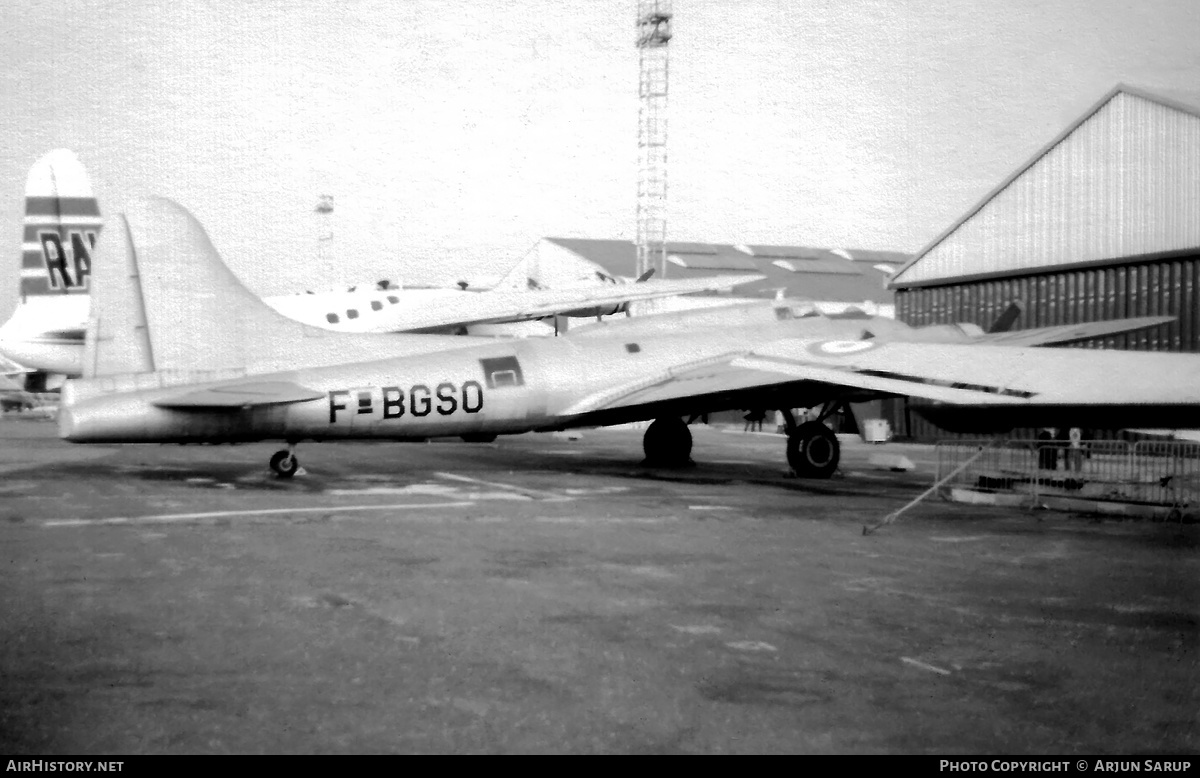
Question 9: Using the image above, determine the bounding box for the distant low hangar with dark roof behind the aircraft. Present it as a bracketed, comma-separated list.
[522, 238, 908, 317]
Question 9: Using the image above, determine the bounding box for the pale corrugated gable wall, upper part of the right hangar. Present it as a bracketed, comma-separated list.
[895, 91, 1200, 285]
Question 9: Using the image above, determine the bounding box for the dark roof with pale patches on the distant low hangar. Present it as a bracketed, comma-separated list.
[546, 238, 908, 304]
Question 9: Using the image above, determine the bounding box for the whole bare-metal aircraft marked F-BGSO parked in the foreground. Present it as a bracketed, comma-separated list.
[59, 198, 1200, 477]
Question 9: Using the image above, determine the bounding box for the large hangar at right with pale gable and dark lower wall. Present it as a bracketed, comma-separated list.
[889, 84, 1200, 438]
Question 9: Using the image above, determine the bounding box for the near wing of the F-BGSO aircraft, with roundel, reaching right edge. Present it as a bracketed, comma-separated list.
[563, 339, 1200, 415]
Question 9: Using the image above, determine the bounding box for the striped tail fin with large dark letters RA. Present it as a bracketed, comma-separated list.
[20, 149, 103, 299]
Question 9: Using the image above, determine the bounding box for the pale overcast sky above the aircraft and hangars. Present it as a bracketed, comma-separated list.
[0, 0, 1200, 312]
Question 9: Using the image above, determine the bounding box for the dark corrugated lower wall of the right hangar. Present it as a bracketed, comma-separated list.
[888, 253, 1200, 439]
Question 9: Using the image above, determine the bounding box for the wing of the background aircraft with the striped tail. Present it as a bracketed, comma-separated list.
[350, 275, 763, 333]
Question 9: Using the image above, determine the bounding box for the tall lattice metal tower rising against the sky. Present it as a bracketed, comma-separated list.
[637, 0, 671, 277]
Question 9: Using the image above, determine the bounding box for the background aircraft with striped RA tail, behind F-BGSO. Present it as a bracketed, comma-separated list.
[0, 149, 761, 383]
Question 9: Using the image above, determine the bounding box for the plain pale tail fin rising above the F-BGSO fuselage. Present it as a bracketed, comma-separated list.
[84, 197, 473, 381]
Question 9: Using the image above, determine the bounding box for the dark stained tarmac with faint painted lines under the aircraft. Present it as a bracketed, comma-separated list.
[0, 419, 1200, 756]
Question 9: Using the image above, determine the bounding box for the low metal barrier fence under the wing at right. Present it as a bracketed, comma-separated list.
[936, 439, 1200, 516]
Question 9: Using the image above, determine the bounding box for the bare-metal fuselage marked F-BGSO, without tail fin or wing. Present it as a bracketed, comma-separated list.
[59, 321, 825, 443]
